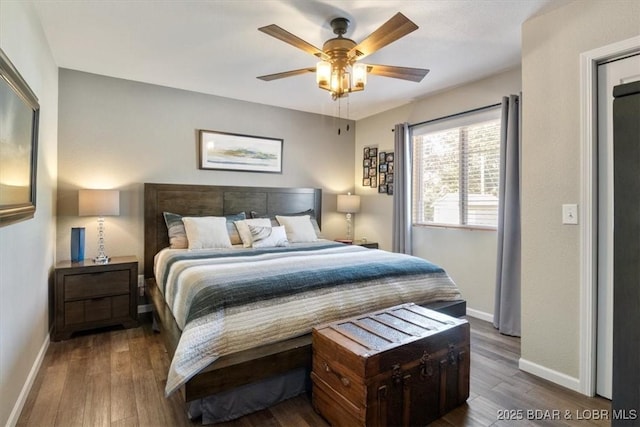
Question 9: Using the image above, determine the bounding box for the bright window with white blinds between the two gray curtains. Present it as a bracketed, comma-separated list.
[411, 106, 500, 228]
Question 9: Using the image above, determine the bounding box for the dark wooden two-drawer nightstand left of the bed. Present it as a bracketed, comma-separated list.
[52, 256, 138, 341]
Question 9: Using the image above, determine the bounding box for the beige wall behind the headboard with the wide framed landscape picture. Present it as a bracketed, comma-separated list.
[56, 69, 355, 268]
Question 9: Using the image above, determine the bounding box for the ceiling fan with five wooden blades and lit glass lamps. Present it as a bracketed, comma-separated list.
[258, 12, 429, 100]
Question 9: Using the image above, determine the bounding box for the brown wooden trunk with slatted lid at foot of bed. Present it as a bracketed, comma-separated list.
[311, 304, 469, 427]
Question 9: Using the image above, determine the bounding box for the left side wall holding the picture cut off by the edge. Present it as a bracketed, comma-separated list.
[0, 1, 58, 426]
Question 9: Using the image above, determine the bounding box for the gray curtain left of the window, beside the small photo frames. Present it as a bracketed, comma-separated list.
[392, 123, 412, 254]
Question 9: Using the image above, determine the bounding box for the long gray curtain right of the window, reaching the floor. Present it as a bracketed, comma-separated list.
[493, 95, 520, 336]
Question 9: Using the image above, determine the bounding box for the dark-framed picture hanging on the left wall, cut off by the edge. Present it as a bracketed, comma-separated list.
[0, 49, 40, 226]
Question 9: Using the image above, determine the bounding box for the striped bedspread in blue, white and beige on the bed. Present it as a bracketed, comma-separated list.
[154, 240, 460, 395]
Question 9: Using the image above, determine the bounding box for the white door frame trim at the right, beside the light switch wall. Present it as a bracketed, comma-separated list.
[578, 36, 640, 396]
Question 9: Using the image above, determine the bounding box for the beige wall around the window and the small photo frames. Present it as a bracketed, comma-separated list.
[354, 68, 521, 318]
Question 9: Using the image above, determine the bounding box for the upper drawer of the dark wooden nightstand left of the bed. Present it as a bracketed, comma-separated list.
[64, 270, 130, 301]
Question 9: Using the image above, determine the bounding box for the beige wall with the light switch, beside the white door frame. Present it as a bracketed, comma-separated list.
[521, 0, 640, 386]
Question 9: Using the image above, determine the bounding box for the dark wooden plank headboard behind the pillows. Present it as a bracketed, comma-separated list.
[144, 183, 322, 278]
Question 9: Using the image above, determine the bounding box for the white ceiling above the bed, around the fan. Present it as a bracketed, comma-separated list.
[34, 0, 567, 120]
